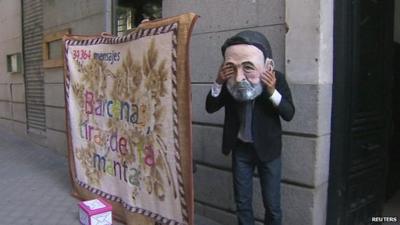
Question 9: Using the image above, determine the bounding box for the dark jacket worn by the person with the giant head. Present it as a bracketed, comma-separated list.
[206, 71, 295, 161]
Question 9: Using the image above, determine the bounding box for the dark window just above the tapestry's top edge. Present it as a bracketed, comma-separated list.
[113, 0, 162, 36]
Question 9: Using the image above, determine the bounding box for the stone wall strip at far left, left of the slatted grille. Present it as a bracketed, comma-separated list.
[0, 1, 26, 136]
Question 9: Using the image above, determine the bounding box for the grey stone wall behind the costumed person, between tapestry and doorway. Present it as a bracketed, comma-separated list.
[163, 0, 333, 225]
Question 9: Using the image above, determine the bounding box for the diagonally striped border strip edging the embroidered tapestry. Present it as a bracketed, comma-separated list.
[64, 23, 189, 225]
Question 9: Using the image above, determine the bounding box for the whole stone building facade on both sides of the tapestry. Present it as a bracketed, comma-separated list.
[0, 0, 400, 225]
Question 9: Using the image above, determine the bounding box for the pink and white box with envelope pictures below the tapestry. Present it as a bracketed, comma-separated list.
[78, 199, 112, 225]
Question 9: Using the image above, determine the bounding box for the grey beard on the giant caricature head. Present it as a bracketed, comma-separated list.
[226, 79, 262, 102]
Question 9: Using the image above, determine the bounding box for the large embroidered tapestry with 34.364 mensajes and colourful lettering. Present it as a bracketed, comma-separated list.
[63, 13, 197, 225]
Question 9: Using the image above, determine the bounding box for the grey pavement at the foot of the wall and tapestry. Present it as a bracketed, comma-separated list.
[0, 128, 219, 225]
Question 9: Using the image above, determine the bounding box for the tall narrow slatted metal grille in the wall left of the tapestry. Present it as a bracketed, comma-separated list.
[22, 0, 46, 134]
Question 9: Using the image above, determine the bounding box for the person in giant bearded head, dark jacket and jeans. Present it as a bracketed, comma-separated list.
[206, 31, 295, 225]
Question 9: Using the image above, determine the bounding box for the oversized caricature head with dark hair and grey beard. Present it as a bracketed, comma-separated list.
[221, 30, 273, 102]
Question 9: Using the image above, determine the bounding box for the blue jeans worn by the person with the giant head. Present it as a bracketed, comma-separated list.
[232, 141, 282, 225]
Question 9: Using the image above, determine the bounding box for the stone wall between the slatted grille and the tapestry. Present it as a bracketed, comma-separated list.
[43, 0, 106, 154]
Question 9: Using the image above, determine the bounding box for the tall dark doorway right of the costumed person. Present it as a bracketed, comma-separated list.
[326, 0, 400, 225]
